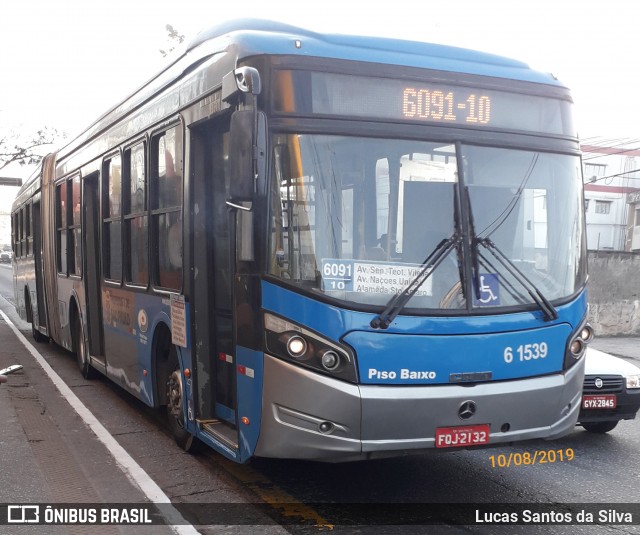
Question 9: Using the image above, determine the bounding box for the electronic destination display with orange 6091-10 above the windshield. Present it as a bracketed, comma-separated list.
[274, 71, 576, 136]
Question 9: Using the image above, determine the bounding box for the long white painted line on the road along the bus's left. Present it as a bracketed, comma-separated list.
[0, 310, 198, 535]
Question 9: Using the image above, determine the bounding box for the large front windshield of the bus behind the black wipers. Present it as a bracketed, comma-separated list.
[269, 134, 585, 311]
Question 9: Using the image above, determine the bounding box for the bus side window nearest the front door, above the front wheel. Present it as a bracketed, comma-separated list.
[151, 125, 182, 290]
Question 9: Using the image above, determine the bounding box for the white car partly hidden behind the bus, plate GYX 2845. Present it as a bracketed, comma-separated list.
[578, 348, 640, 433]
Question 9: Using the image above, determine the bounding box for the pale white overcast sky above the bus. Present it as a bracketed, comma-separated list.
[0, 0, 640, 193]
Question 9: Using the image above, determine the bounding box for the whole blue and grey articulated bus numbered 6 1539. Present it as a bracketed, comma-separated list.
[13, 20, 591, 462]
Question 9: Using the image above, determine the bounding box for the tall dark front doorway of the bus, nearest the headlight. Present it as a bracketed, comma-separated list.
[189, 118, 237, 445]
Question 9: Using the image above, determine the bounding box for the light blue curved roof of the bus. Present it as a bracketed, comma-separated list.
[59, 19, 563, 163]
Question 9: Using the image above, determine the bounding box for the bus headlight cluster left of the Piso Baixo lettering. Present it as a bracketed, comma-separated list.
[264, 313, 358, 383]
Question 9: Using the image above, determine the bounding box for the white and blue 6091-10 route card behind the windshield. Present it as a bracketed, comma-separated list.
[322, 258, 432, 297]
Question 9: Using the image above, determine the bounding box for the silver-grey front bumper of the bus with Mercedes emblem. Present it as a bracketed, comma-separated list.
[255, 355, 584, 462]
